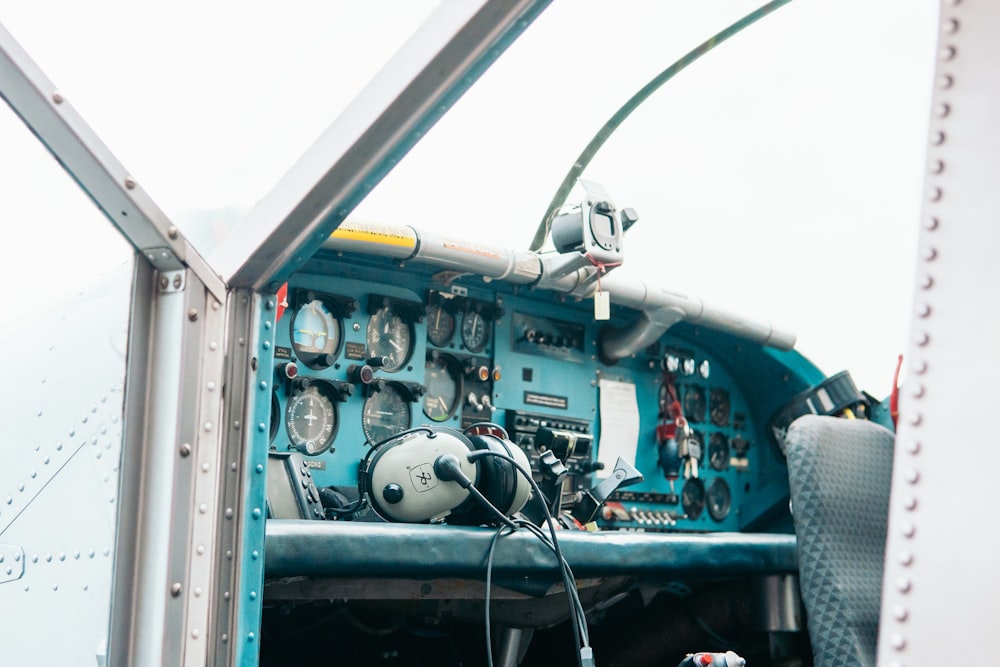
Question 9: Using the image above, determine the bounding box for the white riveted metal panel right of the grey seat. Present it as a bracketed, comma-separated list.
[878, 0, 1000, 667]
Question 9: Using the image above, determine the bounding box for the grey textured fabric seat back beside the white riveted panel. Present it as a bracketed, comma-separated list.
[785, 415, 893, 667]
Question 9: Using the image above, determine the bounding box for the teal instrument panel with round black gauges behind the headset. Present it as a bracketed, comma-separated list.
[270, 264, 787, 531]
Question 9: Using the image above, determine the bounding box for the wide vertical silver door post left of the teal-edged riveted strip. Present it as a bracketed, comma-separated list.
[109, 261, 226, 665]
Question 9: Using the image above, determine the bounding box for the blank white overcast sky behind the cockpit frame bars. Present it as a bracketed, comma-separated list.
[0, 0, 937, 395]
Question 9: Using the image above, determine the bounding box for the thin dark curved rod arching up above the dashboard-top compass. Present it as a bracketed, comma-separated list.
[529, 0, 791, 252]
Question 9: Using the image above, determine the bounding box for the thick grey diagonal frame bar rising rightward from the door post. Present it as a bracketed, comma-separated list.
[211, 0, 548, 292]
